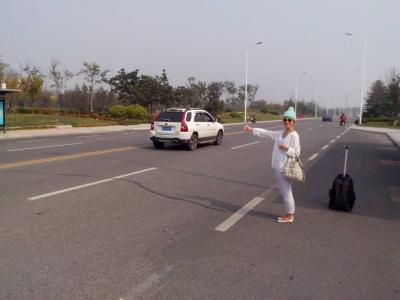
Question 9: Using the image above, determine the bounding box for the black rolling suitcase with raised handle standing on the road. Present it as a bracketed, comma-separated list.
[329, 146, 356, 211]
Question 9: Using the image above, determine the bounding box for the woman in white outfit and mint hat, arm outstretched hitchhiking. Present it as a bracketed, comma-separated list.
[244, 107, 301, 223]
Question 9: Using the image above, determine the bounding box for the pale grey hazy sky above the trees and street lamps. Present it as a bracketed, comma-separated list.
[0, 0, 400, 107]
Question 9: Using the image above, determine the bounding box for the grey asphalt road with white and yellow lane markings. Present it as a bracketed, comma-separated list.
[0, 120, 400, 300]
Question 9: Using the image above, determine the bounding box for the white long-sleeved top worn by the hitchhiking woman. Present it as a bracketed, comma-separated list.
[253, 128, 301, 171]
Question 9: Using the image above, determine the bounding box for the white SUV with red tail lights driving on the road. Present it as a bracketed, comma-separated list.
[150, 108, 224, 151]
